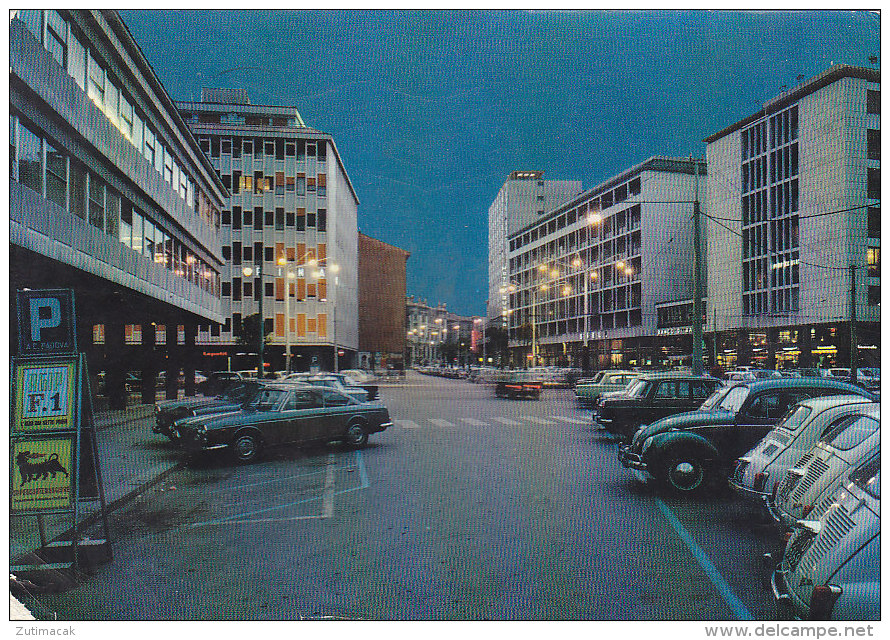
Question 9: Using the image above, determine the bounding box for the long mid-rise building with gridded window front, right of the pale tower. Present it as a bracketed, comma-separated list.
[501, 157, 706, 369]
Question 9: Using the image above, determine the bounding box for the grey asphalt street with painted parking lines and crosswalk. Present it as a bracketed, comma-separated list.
[12, 372, 775, 620]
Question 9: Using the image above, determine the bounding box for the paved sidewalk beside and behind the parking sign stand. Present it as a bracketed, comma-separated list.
[9, 394, 183, 564]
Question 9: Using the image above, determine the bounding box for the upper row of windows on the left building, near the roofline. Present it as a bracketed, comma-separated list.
[17, 9, 219, 227]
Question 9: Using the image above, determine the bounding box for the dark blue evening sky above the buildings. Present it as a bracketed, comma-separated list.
[121, 11, 880, 315]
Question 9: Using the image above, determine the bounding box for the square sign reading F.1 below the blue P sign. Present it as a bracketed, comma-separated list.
[12, 361, 77, 431]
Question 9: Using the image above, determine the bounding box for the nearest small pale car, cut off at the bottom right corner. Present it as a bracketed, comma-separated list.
[771, 456, 881, 620]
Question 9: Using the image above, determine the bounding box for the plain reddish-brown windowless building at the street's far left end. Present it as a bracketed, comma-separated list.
[356, 233, 411, 368]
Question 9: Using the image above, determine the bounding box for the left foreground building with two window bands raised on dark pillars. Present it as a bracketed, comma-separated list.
[9, 10, 228, 406]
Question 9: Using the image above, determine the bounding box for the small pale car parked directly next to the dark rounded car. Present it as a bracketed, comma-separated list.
[729, 396, 869, 509]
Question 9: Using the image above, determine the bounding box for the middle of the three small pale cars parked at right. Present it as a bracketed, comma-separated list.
[773, 403, 881, 526]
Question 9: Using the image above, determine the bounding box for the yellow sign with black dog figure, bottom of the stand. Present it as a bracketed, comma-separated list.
[10, 437, 75, 511]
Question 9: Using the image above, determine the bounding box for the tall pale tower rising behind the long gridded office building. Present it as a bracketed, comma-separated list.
[487, 171, 581, 325]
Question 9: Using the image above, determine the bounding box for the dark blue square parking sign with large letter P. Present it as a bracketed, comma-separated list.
[16, 289, 77, 356]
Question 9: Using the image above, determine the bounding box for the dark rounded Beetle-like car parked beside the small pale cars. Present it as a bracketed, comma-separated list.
[618, 378, 875, 492]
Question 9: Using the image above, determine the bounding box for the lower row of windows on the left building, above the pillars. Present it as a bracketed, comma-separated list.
[9, 115, 219, 296]
